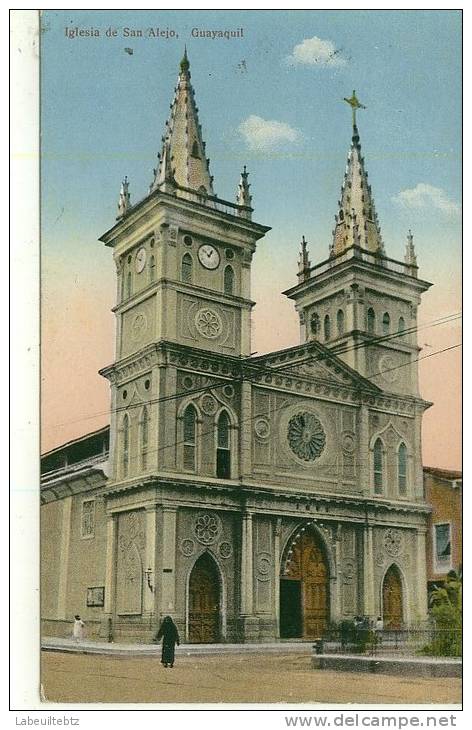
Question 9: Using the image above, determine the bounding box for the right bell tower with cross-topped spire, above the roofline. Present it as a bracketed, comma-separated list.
[284, 91, 431, 396]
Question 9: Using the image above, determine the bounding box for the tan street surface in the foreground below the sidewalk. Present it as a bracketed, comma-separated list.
[41, 647, 461, 705]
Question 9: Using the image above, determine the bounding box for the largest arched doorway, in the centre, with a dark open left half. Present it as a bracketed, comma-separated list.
[280, 530, 329, 639]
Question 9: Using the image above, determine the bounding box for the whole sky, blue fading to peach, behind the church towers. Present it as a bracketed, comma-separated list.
[41, 10, 462, 469]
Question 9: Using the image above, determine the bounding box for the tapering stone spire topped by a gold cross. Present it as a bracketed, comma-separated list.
[330, 101, 385, 255]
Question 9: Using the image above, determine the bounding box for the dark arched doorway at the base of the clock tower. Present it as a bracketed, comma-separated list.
[188, 553, 220, 644]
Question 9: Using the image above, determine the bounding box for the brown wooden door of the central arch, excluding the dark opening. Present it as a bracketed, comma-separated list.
[285, 530, 329, 639]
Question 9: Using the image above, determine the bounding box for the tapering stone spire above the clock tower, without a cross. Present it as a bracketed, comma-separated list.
[150, 47, 214, 195]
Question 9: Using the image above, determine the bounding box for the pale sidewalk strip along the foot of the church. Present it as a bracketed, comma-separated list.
[41, 636, 313, 656]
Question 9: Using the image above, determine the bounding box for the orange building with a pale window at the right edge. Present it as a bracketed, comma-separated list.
[423, 466, 462, 590]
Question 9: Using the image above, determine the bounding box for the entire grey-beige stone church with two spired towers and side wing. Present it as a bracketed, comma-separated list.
[41, 55, 430, 643]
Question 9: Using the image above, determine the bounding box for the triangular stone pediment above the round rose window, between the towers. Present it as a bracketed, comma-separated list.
[251, 342, 381, 393]
